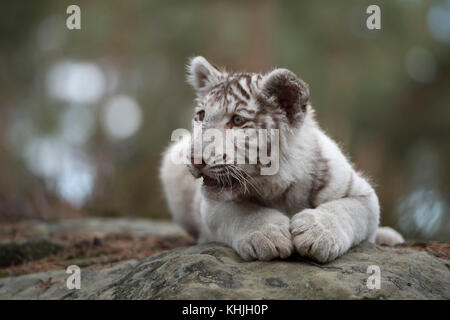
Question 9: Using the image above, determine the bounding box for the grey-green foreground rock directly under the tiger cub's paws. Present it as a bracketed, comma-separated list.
[0, 243, 450, 299]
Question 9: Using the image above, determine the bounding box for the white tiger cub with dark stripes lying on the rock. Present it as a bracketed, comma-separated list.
[160, 57, 404, 263]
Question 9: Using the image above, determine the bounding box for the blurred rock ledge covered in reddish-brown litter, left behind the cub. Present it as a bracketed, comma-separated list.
[0, 217, 194, 278]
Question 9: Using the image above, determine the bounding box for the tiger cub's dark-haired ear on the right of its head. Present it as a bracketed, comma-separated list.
[262, 69, 309, 125]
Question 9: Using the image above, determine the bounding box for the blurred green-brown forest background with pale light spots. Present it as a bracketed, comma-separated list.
[0, 0, 450, 241]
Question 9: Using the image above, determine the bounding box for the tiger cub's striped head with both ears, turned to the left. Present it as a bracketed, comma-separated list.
[188, 57, 309, 199]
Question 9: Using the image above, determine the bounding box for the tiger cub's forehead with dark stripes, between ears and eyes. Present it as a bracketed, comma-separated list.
[206, 73, 262, 112]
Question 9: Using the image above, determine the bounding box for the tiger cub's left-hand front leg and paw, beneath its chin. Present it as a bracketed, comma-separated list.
[201, 200, 293, 261]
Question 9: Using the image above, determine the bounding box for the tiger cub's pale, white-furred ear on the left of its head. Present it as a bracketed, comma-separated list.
[187, 56, 222, 94]
